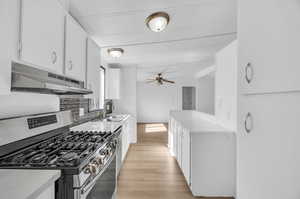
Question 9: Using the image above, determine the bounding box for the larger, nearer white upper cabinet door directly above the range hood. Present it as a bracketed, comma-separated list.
[20, 0, 64, 73]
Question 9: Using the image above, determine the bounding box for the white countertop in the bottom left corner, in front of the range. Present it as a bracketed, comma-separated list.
[0, 169, 60, 199]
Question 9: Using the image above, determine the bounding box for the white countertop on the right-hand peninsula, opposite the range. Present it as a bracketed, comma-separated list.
[170, 111, 232, 133]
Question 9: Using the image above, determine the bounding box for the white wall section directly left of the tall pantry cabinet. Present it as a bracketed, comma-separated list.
[215, 41, 237, 131]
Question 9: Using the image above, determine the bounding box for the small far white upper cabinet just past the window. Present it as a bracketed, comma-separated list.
[105, 68, 121, 99]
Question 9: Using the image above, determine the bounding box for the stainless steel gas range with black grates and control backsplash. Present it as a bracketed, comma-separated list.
[0, 111, 121, 199]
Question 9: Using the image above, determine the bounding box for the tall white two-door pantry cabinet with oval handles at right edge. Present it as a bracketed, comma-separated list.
[237, 0, 300, 199]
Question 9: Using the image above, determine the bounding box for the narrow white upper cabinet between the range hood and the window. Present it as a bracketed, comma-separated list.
[87, 39, 101, 110]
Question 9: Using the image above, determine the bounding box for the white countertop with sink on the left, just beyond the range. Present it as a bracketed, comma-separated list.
[71, 115, 130, 132]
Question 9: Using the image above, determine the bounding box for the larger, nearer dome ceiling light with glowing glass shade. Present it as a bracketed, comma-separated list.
[146, 12, 170, 32]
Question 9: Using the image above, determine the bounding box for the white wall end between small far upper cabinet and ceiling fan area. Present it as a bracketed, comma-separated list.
[113, 66, 137, 143]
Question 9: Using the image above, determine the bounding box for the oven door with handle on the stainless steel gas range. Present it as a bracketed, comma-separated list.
[80, 154, 117, 199]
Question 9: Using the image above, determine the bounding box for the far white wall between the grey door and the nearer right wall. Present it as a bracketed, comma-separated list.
[197, 75, 215, 115]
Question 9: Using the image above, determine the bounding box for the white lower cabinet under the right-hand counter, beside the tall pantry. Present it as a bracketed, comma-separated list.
[169, 117, 236, 197]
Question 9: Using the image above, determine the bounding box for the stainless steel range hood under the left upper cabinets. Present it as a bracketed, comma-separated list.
[11, 62, 93, 95]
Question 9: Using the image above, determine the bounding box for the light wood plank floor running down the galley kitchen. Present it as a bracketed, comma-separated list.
[117, 124, 232, 199]
